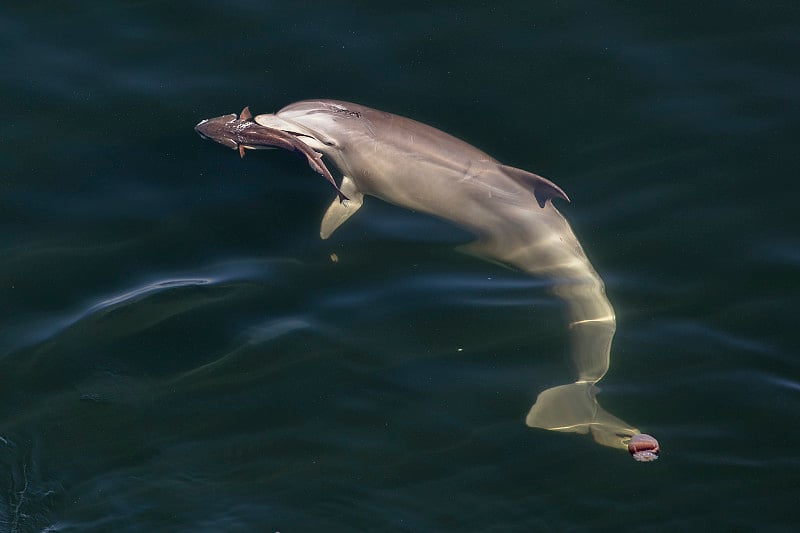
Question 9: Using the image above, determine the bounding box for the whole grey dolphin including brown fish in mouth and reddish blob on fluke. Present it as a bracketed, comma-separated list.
[195, 100, 659, 461]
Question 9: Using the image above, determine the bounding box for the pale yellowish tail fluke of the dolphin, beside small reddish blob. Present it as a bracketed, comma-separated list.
[525, 381, 639, 449]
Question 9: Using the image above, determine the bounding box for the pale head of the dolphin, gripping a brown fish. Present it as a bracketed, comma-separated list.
[255, 100, 374, 153]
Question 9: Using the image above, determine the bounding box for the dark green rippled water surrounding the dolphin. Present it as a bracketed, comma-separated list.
[0, 1, 800, 533]
